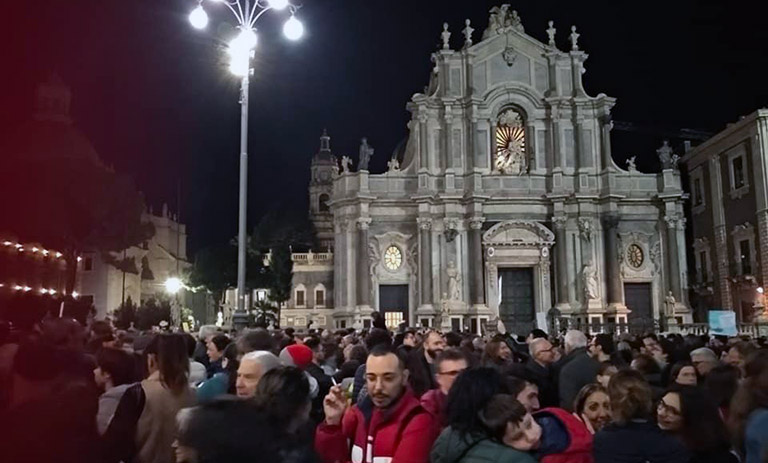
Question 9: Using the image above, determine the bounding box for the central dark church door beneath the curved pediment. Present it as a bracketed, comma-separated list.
[499, 267, 536, 335]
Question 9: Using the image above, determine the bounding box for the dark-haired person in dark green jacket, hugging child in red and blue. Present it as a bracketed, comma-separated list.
[430, 367, 537, 463]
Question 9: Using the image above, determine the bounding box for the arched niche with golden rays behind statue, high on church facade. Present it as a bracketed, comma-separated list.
[493, 109, 528, 175]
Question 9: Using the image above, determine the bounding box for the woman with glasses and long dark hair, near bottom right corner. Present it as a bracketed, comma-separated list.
[656, 387, 738, 463]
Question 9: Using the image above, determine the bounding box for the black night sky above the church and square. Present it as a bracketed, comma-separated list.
[0, 0, 768, 256]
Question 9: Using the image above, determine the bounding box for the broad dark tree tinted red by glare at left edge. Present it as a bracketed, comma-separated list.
[0, 156, 154, 294]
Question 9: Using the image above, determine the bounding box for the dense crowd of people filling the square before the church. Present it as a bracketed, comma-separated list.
[0, 317, 768, 463]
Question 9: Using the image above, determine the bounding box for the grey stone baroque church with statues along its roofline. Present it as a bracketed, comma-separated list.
[294, 5, 691, 333]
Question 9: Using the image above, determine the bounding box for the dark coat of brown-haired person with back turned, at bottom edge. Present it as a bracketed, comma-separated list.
[593, 420, 690, 463]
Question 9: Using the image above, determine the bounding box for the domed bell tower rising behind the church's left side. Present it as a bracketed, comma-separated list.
[309, 130, 339, 250]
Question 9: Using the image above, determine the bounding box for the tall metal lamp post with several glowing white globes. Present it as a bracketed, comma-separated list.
[189, 0, 304, 330]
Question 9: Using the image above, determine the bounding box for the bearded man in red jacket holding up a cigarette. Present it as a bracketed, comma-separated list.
[315, 346, 437, 463]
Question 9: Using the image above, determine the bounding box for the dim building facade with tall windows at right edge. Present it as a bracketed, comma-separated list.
[682, 109, 768, 322]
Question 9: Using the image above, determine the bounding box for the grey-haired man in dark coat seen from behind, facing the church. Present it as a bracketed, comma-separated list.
[558, 330, 600, 411]
